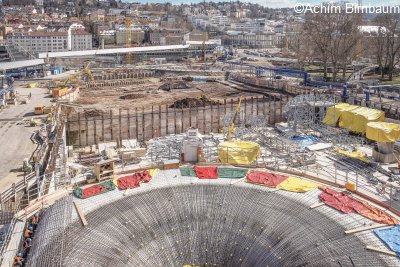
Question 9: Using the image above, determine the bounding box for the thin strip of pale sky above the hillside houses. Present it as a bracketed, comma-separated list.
[127, 0, 400, 8]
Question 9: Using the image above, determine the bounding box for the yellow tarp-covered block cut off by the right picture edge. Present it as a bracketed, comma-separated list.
[367, 122, 400, 142]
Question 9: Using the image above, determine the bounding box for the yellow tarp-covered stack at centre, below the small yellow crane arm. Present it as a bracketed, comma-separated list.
[218, 140, 260, 165]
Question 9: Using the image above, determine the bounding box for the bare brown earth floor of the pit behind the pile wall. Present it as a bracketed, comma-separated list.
[76, 78, 262, 111]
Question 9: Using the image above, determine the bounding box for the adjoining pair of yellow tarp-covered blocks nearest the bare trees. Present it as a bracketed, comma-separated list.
[323, 103, 385, 134]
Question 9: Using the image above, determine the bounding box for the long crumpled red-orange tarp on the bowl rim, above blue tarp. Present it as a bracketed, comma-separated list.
[319, 188, 399, 225]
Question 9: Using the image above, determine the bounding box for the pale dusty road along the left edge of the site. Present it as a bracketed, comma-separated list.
[0, 82, 51, 191]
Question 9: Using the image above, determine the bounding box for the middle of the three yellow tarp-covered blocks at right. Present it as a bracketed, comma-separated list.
[339, 107, 385, 134]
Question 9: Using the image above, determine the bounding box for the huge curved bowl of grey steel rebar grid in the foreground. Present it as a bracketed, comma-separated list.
[26, 170, 400, 266]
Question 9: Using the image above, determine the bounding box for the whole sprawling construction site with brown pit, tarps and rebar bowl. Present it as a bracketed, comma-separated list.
[0, 47, 400, 267]
